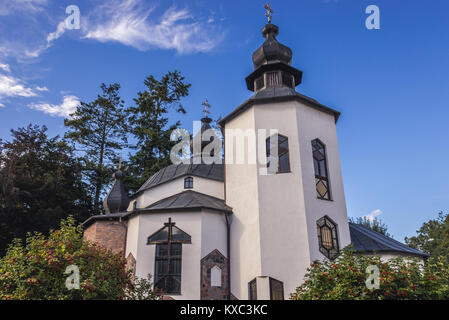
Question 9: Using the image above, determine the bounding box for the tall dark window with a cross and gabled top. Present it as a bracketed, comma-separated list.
[147, 218, 191, 294]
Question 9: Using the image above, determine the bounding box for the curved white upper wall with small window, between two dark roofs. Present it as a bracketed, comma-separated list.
[128, 176, 224, 211]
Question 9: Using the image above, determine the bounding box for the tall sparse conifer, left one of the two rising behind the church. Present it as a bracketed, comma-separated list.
[64, 83, 127, 212]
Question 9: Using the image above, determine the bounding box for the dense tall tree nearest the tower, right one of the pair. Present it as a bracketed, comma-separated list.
[126, 71, 191, 191]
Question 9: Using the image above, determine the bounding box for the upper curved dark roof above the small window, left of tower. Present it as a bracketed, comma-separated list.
[133, 163, 224, 197]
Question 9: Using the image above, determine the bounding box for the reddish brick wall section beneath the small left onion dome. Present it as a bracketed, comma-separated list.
[84, 220, 126, 255]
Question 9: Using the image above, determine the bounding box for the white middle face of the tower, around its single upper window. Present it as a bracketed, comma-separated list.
[254, 102, 310, 298]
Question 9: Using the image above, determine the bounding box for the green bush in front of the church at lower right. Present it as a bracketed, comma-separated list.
[291, 249, 449, 300]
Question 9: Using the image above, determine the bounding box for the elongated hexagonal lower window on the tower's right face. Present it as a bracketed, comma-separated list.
[317, 216, 339, 259]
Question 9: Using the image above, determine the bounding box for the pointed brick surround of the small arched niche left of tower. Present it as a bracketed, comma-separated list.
[201, 249, 229, 300]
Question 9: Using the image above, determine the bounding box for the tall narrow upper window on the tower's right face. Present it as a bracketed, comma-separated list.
[312, 139, 331, 200]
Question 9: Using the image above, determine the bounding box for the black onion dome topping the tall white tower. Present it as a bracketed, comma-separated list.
[253, 23, 293, 69]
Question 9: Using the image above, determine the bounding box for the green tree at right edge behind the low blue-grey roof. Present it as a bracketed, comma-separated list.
[405, 212, 449, 262]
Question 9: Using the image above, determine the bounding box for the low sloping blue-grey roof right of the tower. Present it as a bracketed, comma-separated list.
[349, 222, 429, 257]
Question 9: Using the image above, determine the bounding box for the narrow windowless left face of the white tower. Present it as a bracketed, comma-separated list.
[225, 105, 261, 299]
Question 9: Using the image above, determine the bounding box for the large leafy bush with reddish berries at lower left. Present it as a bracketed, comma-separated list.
[0, 217, 159, 300]
